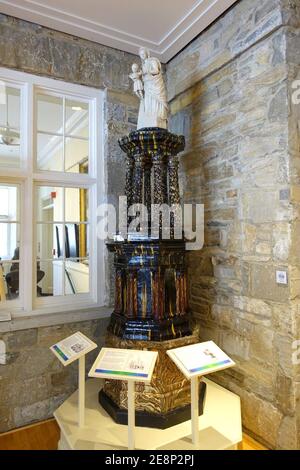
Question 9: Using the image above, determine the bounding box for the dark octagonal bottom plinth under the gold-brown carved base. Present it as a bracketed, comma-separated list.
[99, 382, 206, 429]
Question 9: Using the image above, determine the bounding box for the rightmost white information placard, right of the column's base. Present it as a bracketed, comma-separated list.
[167, 341, 235, 379]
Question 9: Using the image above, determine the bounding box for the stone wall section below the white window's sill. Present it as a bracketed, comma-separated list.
[0, 319, 108, 433]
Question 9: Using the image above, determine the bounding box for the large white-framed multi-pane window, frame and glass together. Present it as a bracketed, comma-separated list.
[0, 69, 103, 315]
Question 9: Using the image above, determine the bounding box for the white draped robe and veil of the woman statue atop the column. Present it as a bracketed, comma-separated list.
[137, 57, 168, 129]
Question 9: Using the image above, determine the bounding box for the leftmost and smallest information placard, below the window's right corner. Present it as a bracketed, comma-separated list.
[50, 331, 97, 366]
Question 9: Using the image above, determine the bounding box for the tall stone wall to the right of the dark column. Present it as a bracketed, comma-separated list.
[167, 0, 300, 449]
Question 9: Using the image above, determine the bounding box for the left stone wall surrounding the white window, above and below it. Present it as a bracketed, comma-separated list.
[0, 15, 137, 432]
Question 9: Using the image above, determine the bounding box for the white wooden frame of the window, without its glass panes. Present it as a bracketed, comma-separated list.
[0, 67, 106, 319]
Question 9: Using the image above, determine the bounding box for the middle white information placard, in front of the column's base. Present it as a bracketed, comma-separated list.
[89, 348, 158, 383]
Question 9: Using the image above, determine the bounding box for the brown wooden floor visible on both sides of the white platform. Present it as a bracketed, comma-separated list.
[0, 420, 267, 450]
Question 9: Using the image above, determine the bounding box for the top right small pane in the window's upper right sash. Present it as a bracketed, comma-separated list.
[65, 100, 89, 139]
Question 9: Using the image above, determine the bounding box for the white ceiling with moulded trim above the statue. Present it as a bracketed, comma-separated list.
[0, 0, 237, 62]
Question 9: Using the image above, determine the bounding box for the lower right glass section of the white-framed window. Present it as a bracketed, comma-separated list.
[36, 186, 90, 296]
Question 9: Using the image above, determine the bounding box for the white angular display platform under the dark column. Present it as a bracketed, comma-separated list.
[54, 378, 242, 450]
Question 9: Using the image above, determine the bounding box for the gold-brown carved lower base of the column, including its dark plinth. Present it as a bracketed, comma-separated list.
[99, 331, 205, 429]
